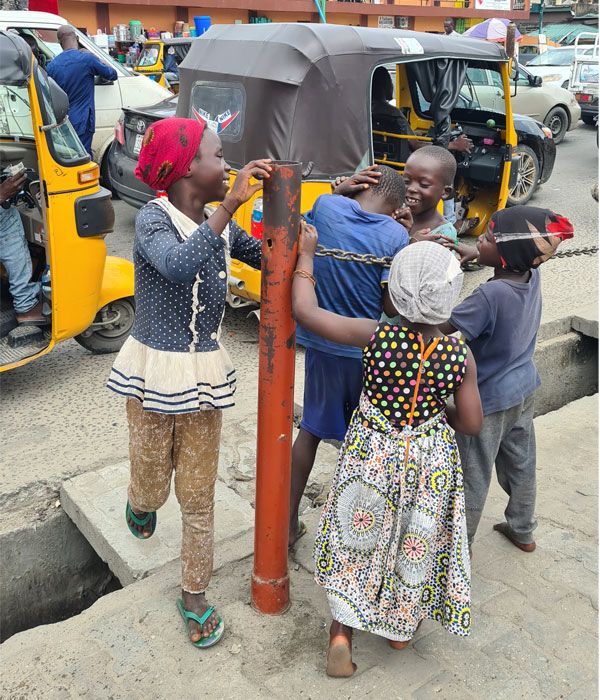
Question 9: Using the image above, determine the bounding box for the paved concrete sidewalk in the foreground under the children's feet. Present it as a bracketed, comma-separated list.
[0, 397, 598, 700]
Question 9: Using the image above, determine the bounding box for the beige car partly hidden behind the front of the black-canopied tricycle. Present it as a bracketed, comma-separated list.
[467, 66, 581, 143]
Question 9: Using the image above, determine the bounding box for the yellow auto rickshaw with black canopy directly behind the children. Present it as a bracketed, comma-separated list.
[177, 24, 518, 304]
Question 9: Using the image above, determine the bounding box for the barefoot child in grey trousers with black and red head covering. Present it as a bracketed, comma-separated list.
[444, 206, 573, 552]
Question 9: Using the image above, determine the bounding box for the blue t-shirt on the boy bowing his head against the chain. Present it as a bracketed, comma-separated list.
[296, 194, 408, 358]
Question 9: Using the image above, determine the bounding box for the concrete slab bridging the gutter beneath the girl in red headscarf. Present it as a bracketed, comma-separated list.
[61, 462, 254, 586]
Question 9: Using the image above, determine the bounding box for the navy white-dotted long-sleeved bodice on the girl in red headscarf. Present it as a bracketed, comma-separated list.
[131, 202, 261, 352]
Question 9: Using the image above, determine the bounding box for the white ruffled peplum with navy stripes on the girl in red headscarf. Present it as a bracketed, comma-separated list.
[107, 336, 236, 413]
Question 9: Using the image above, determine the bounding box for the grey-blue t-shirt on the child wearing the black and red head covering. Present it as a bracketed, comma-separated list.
[450, 270, 542, 416]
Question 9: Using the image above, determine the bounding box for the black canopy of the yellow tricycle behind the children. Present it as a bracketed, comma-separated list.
[177, 23, 508, 178]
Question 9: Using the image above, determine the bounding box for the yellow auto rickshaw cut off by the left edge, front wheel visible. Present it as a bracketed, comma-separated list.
[0, 31, 134, 372]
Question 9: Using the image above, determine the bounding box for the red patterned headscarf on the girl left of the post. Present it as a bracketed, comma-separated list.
[135, 117, 206, 190]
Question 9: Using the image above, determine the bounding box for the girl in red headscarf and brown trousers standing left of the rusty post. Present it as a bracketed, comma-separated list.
[108, 117, 271, 647]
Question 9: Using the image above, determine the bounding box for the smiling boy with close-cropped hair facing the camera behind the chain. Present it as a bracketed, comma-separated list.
[403, 146, 458, 242]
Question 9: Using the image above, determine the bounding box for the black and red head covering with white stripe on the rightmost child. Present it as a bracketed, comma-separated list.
[489, 205, 573, 272]
